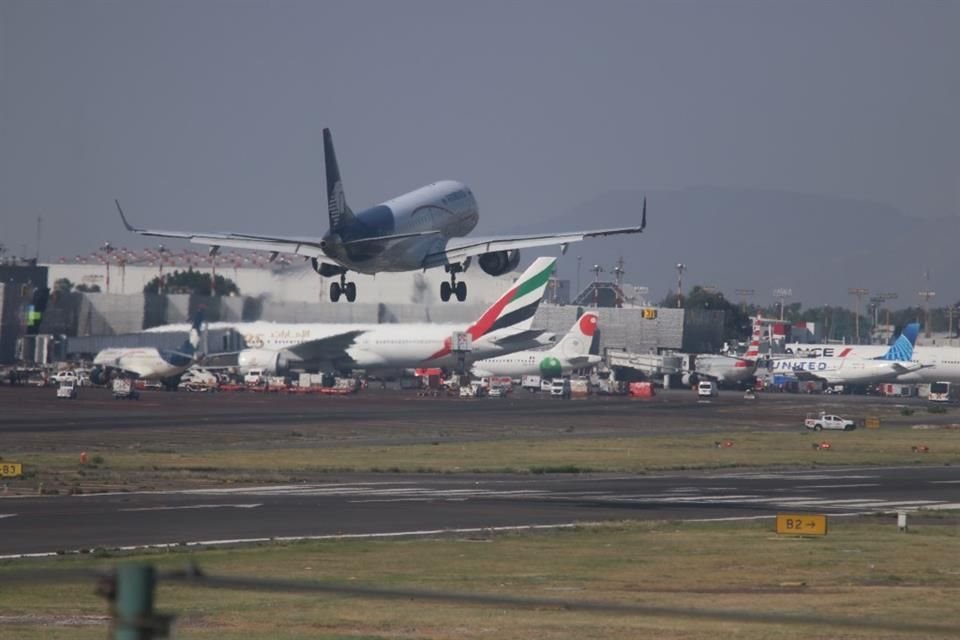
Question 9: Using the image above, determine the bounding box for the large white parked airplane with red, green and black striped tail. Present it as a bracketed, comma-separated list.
[150, 258, 557, 375]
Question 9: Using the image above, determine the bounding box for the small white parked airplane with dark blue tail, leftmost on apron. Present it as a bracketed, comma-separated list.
[90, 311, 203, 388]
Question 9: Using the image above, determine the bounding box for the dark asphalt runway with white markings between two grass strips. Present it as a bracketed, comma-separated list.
[0, 466, 960, 557]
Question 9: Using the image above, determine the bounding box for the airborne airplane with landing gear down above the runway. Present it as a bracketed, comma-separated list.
[116, 129, 647, 302]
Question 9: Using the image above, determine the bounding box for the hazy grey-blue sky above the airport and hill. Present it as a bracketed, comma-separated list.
[0, 0, 960, 296]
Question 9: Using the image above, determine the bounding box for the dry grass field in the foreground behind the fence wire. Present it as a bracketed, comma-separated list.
[0, 514, 960, 640]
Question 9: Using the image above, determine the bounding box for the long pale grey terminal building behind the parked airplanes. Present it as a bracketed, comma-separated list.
[0, 247, 723, 364]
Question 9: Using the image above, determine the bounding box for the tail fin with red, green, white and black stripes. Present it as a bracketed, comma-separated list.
[467, 258, 557, 340]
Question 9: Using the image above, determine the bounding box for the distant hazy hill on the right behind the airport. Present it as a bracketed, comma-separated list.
[506, 187, 960, 307]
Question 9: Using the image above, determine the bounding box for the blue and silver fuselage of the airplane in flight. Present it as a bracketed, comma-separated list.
[322, 180, 480, 274]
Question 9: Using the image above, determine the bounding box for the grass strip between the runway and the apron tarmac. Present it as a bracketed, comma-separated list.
[8, 429, 960, 493]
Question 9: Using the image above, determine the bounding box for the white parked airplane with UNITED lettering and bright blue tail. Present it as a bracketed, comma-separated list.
[769, 323, 922, 384]
